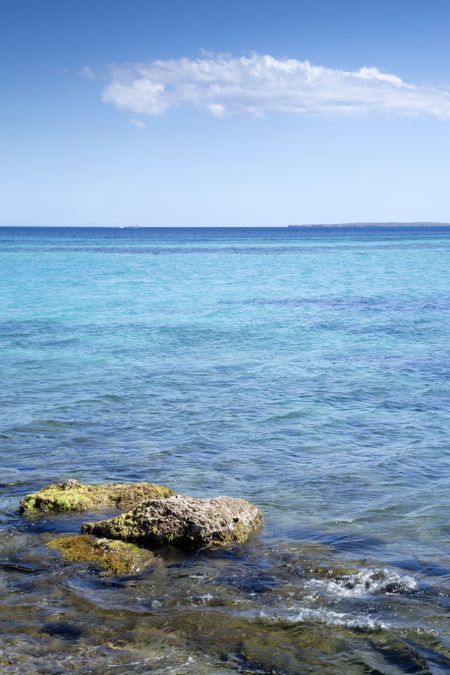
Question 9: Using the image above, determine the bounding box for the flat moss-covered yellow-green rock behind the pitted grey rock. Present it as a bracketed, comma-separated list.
[20, 478, 174, 515]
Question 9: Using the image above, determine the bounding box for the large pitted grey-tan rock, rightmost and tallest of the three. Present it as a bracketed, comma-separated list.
[82, 495, 262, 549]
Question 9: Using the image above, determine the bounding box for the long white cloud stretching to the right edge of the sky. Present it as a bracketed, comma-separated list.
[99, 54, 450, 119]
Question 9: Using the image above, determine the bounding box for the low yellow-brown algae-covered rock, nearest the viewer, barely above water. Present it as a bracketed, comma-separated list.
[47, 534, 155, 574]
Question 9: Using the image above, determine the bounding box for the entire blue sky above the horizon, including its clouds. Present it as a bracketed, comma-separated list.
[0, 0, 450, 227]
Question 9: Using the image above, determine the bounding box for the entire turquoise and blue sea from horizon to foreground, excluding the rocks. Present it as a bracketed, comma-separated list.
[0, 227, 450, 673]
